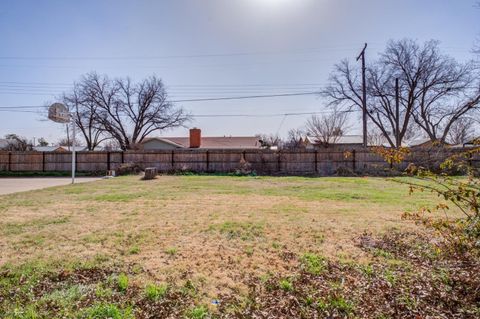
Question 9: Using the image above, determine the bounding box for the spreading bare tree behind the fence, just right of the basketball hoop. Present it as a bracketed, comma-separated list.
[69, 73, 189, 150]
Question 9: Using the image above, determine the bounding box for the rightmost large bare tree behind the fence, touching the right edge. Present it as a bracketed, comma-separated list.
[382, 40, 480, 143]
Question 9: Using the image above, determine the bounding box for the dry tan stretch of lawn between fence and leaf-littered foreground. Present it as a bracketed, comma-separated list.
[0, 176, 450, 298]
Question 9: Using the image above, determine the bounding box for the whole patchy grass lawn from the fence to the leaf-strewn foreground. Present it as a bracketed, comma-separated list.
[0, 176, 480, 318]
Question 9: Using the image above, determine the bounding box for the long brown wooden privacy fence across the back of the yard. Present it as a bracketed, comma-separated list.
[0, 149, 480, 176]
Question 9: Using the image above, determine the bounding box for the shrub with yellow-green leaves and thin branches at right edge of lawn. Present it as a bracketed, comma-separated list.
[378, 148, 480, 257]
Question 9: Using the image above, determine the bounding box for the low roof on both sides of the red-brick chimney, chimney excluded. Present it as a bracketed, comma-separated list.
[142, 136, 261, 149]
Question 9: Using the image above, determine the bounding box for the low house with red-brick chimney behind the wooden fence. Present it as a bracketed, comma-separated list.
[141, 128, 262, 151]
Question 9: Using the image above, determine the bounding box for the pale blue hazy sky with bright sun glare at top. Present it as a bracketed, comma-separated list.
[0, 0, 480, 142]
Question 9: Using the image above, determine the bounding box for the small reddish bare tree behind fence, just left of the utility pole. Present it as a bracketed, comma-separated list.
[306, 109, 347, 147]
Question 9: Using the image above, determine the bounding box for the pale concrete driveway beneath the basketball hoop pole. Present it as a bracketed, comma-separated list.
[0, 177, 100, 195]
